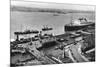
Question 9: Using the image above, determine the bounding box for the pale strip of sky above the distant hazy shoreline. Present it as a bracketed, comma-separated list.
[11, 0, 95, 11]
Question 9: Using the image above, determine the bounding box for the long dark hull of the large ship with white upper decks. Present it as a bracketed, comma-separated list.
[65, 23, 95, 31]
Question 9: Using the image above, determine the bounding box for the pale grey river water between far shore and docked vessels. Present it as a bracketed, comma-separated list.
[10, 11, 95, 39]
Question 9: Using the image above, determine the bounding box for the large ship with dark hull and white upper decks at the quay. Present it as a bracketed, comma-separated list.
[65, 18, 95, 31]
